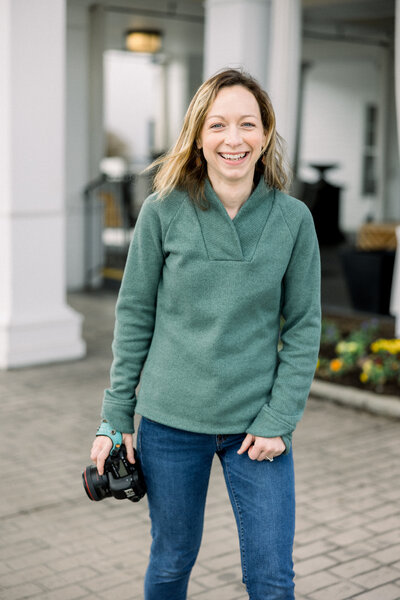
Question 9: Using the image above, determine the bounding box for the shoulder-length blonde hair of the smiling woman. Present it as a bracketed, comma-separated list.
[146, 69, 291, 208]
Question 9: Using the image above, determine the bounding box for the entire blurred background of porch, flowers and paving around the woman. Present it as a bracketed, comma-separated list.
[0, 5, 400, 600]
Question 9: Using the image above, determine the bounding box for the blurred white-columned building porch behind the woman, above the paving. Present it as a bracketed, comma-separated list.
[0, 0, 400, 368]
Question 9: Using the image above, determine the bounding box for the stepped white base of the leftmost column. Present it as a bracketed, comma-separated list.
[0, 306, 86, 369]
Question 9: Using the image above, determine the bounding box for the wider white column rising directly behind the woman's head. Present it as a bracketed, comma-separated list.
[204, 0, 270, 86]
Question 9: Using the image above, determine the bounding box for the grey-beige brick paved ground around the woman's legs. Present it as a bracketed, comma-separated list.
[0, 294, 400, 600]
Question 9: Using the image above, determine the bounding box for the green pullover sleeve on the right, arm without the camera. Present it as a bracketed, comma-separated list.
[247, 205, 321, 453]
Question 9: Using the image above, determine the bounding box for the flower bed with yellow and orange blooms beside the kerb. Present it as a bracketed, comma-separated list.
[315, 317, 400, 399]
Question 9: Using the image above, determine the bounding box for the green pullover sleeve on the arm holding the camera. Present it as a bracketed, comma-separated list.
[101, 196, 164, 433]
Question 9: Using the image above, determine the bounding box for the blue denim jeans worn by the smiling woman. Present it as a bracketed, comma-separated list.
[137, 417, 295, 600]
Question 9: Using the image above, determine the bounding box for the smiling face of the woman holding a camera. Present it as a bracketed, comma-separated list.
[198, 85, 266, 187]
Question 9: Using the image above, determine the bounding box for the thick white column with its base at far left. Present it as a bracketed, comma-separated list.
[0, 0, 85, 368]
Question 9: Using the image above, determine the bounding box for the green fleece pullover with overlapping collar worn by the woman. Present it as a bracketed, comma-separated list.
[102, 179, 321, 452]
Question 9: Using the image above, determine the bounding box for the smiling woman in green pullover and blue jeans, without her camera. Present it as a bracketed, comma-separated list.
[91, 69, 320, 600]
